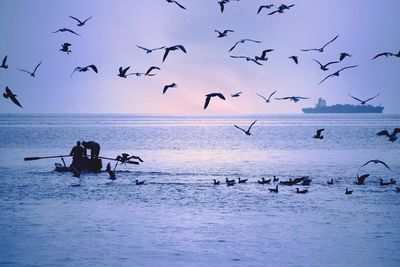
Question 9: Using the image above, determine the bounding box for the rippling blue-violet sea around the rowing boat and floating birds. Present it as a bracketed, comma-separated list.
[0, 114, 400, 267]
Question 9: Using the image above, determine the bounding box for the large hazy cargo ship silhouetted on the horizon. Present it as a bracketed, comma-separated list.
[303, 97, 383, 113]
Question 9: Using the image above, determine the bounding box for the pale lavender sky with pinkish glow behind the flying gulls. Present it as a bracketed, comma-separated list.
[0, 0, 400, 115]
